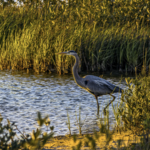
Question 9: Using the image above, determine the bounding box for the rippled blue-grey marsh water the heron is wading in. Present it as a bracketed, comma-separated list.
[0, 71, 125, 136]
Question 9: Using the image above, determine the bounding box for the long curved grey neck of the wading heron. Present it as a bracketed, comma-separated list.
[73, 56, 82, 85]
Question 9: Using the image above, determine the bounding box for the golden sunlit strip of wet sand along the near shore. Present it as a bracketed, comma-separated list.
[45, 131, 140, 150]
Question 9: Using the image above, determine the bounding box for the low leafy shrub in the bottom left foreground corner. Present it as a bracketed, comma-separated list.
[0, 112, 54, 150]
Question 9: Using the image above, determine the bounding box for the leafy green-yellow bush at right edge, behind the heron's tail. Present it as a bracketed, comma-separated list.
[119, 77, 150, 133]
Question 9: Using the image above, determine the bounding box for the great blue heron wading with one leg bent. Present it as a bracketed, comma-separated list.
[57, 50, 122, 115]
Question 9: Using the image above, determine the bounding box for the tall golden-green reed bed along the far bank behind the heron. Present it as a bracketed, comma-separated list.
[0, 0, 150, 74]
